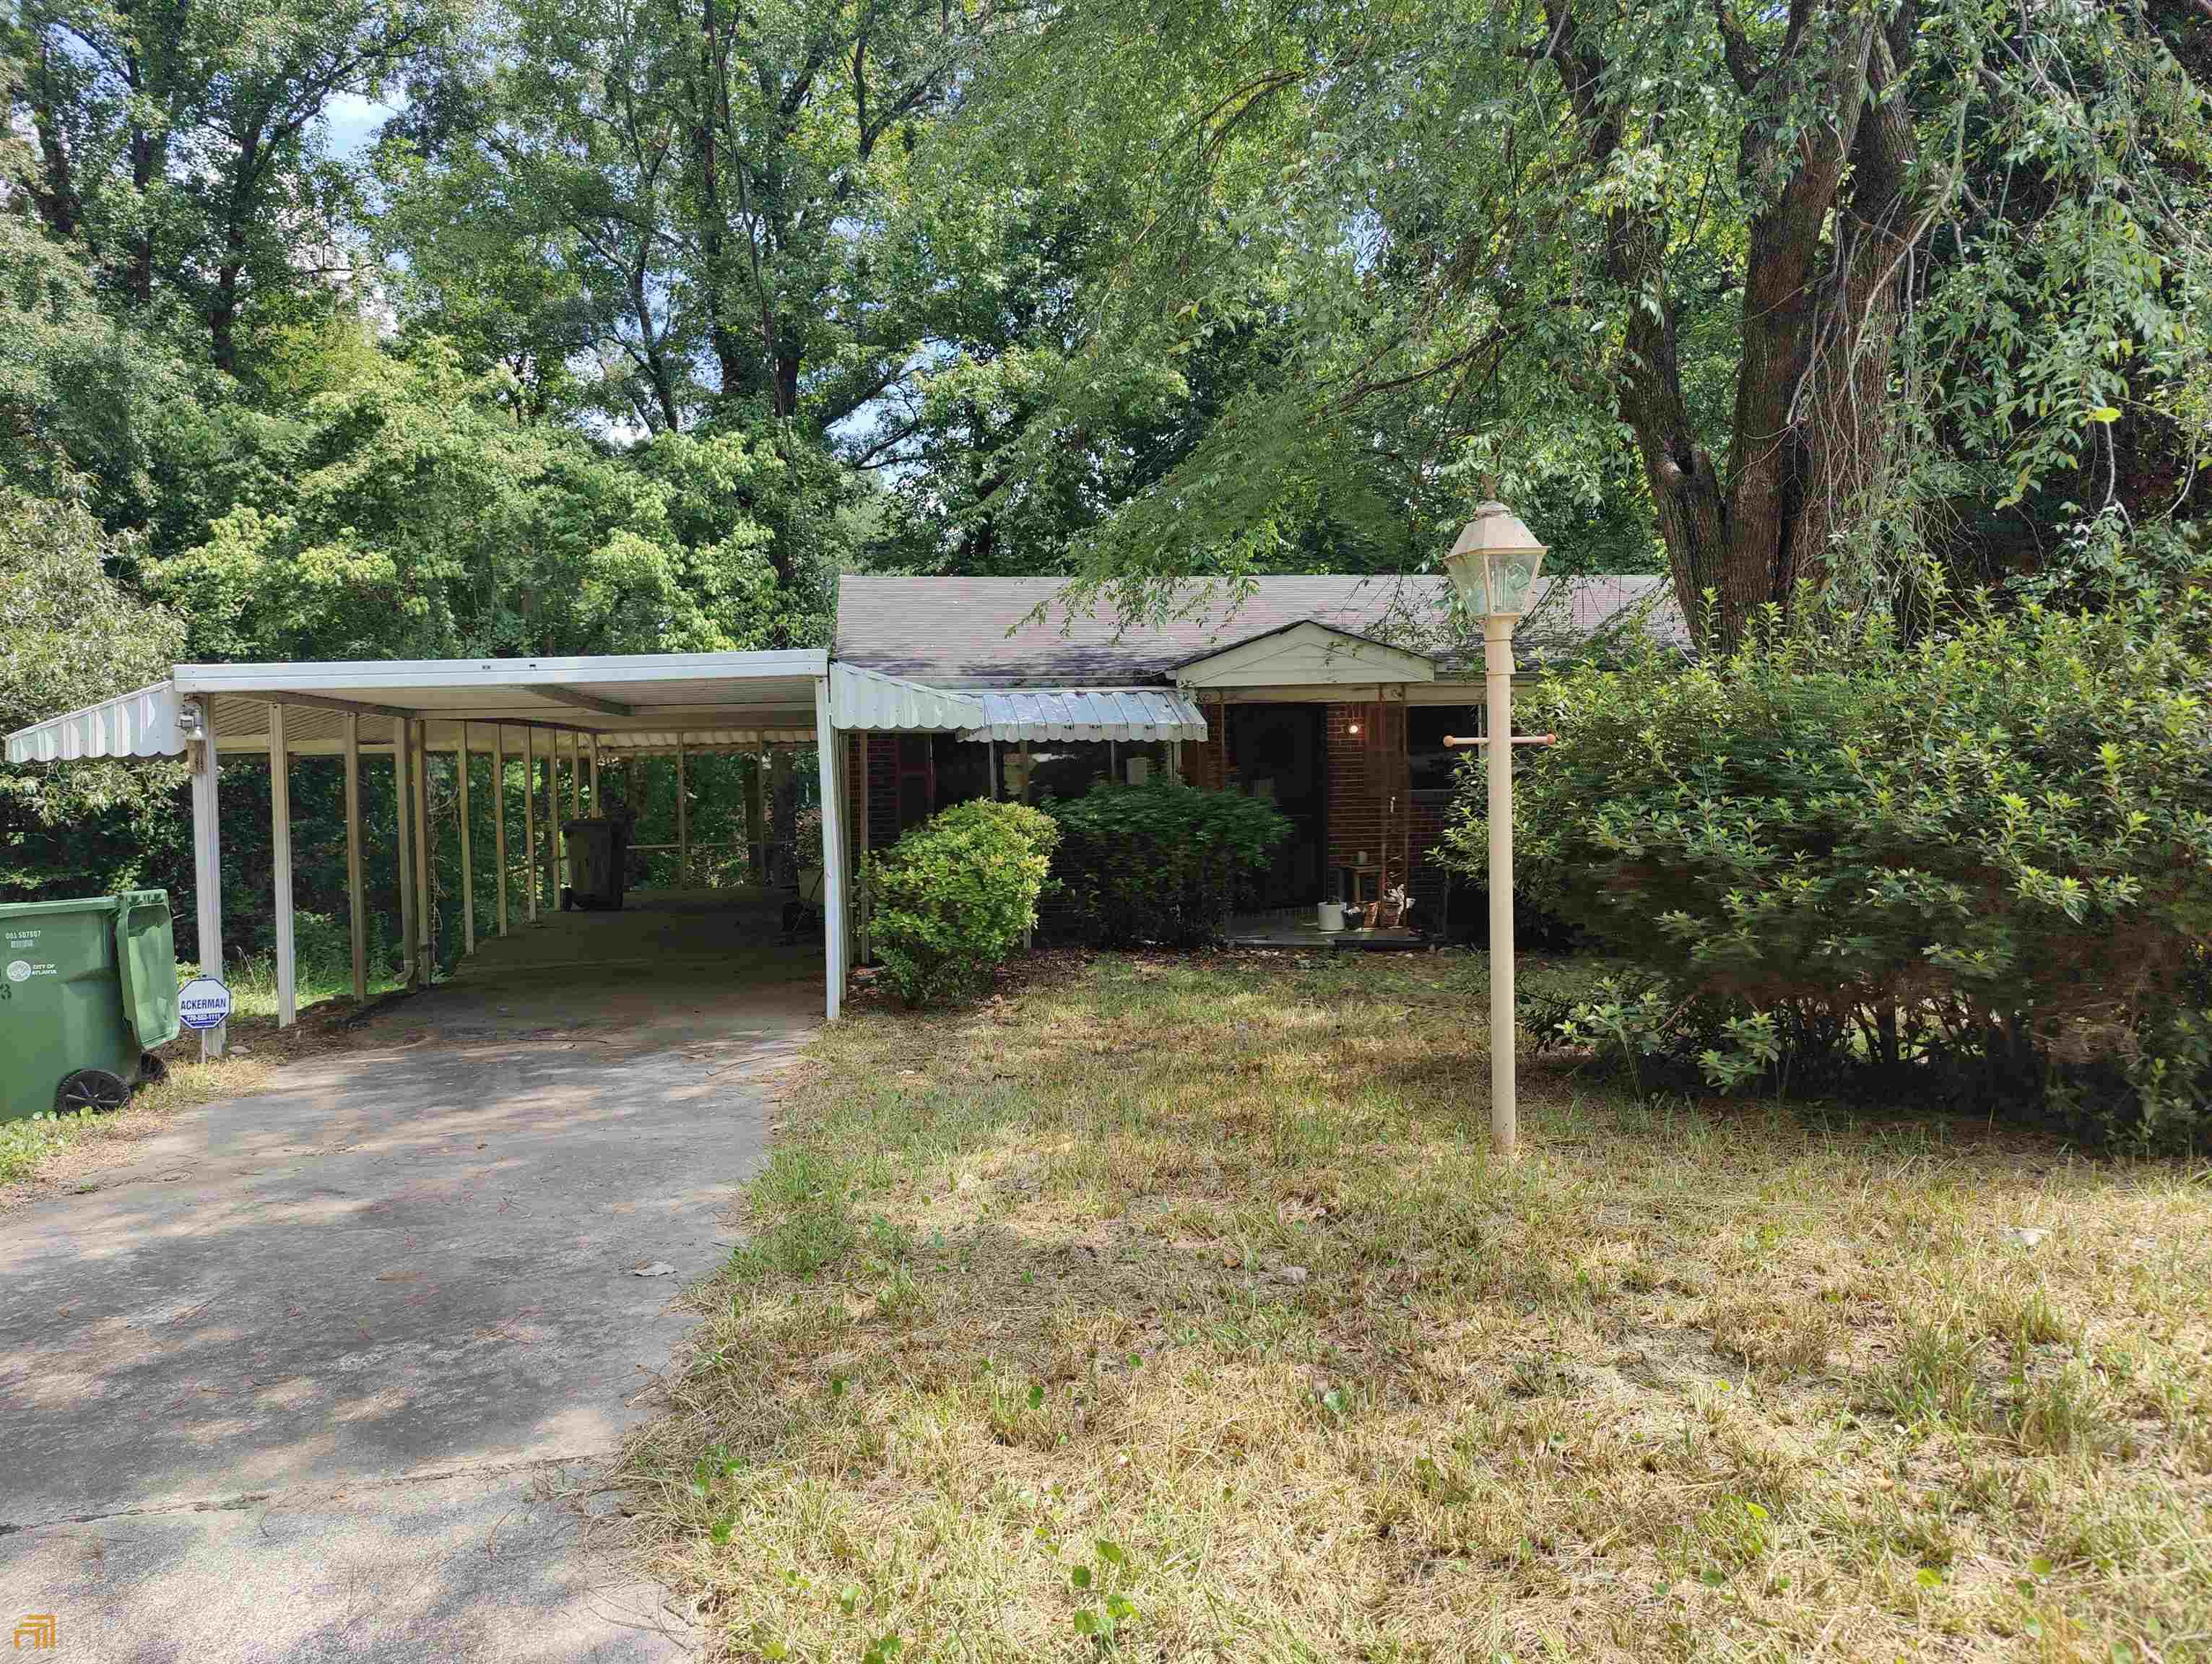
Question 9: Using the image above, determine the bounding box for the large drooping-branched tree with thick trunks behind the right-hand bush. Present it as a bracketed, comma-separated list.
[967, 0, 2212, 644]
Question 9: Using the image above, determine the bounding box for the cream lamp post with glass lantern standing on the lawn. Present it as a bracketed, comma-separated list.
[1444, 502, 1544, 1159]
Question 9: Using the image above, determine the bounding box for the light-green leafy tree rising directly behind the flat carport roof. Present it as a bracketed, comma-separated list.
[157, 325, 814, 659]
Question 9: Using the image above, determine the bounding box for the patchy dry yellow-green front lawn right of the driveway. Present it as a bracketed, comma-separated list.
[630, 956, 2212, 1664]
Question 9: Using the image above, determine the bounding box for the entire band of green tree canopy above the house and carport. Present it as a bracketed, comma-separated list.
[0, 0, 2212, 911]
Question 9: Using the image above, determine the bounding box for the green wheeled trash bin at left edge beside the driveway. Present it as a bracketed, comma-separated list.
[0, 890, 177, 1119]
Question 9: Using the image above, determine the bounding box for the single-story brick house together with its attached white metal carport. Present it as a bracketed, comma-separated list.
[6, 576, 1686, 1051]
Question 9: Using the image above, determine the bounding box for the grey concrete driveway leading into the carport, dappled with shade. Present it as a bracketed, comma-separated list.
[0, 909, 820, 1660]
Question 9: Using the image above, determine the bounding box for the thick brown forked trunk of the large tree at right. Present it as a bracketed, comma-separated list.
[1548, 0, 1911, 649]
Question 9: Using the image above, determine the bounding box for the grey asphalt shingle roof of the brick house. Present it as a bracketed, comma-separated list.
[834, 573, 1688, 688]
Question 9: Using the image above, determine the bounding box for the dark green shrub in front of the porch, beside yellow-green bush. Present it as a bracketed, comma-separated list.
[1044, 776, 1290, 947]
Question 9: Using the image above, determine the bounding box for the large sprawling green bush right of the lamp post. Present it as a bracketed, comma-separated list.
[1449, 595, 2212, 1135]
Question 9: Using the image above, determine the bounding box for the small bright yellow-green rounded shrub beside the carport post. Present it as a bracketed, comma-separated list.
[865, 801, 1059, 1005]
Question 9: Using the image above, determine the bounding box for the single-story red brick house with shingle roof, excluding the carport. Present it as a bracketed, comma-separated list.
[832, 576, 1688, 923]
